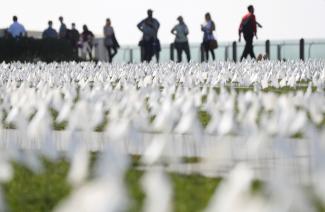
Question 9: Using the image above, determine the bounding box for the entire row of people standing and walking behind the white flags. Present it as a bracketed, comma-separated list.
[4, 5, 262, 62]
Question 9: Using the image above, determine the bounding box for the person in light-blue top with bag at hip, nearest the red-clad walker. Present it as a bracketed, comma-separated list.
[201, 13, 216, 61]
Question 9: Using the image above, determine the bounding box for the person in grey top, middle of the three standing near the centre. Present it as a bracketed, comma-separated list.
[171, 16, 191, 63]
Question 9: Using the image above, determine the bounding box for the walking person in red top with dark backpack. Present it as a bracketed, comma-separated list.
[239, 5, 262, 61]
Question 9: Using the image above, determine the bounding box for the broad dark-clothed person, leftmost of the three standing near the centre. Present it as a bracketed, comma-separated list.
[137, 9, 160, 62]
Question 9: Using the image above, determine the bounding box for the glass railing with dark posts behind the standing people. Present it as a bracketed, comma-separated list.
[95, 39, 325, 63]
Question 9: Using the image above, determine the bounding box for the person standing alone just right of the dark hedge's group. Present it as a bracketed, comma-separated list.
[104, 18, 120, 63]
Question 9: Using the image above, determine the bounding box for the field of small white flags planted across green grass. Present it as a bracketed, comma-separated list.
[0, 60, 325, 212]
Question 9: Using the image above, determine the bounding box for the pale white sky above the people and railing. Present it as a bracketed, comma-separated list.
[0, 0, 325, 45]
